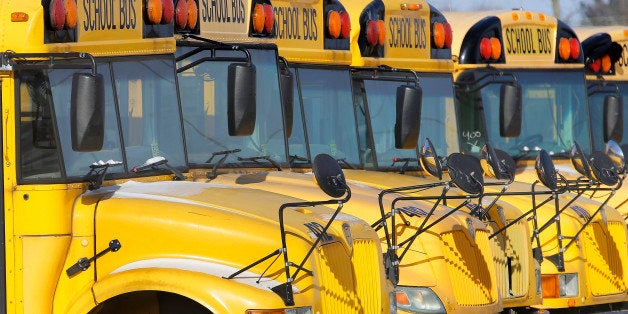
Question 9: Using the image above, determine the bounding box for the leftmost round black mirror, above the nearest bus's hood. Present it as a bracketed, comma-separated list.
[312, 154, 348, 198]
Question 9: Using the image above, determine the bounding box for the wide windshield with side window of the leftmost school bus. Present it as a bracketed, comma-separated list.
[16, 56, 185, 183]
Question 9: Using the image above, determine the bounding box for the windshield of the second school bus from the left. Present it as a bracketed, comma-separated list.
[177, 46, 286, 167]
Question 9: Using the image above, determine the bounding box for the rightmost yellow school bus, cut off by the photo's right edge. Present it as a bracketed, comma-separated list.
[575, 26, 628, 218]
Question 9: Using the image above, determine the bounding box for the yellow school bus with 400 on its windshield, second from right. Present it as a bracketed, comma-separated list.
[445, 10, 627, 310]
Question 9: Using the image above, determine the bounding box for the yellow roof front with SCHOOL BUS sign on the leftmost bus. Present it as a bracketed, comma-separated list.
[0, 0, 175, 56]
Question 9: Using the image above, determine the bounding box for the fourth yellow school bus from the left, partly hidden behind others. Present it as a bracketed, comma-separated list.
[344, 1, 542, 309]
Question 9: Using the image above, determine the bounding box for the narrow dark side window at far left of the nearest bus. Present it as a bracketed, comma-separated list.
[18, 71, 61, 179]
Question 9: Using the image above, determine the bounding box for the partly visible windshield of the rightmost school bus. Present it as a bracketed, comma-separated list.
[589, 81, 628, 151]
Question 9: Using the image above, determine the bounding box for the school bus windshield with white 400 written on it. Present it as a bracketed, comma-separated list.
[458, 70, 591, 158]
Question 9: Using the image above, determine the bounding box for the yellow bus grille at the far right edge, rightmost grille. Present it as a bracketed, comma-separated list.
[582, 222, 626, 296]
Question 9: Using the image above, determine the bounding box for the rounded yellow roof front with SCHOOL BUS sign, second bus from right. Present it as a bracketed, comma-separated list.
[445, 10, 583, 68]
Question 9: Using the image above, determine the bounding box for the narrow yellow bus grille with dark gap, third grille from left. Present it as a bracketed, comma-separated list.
[491, 221, 530, 299]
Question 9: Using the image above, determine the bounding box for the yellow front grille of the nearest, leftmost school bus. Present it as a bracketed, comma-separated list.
[320, 240, 382, 314]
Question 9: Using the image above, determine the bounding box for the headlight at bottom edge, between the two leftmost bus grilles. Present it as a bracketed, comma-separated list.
[396, 286, 445, 314]
